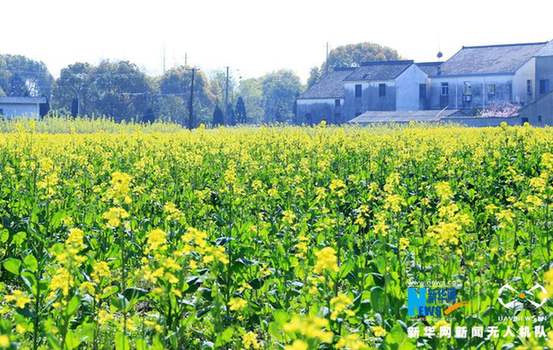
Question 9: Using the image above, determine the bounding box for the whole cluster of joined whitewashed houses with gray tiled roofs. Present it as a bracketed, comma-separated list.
[296, 41, 553, 126]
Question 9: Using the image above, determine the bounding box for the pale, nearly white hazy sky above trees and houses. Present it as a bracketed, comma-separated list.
[0, 0, 553, 80]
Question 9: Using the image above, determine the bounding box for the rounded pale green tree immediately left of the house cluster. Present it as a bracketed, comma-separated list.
[263, 70, 302, 122]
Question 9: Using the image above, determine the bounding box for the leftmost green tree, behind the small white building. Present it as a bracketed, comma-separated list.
[0, 55, 54, 98]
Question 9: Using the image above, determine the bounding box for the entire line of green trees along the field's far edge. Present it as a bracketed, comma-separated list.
[0, 43, 399, 126]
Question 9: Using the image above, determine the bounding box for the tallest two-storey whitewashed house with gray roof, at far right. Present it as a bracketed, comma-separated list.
[430, 42, 553, 110]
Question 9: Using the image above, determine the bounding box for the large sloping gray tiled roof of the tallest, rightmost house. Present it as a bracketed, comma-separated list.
[441, 42, 547, 75]
